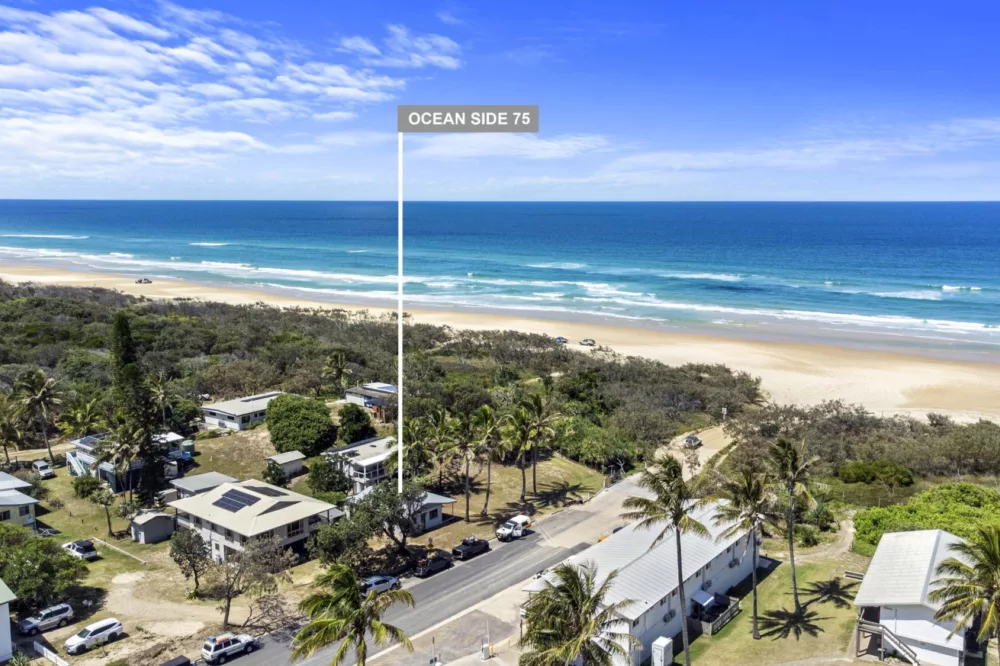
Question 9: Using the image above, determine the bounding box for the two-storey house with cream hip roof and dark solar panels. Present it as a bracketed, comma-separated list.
[167, 479, 344, 562]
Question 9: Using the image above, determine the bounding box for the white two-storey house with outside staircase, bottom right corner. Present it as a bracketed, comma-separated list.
[854, 530, 980, 666]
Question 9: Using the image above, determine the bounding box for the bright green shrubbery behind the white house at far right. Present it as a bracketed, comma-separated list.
[854, 483, 1000, 557]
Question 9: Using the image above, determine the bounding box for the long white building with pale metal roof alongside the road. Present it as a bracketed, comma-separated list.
[525, 498, 753, 666]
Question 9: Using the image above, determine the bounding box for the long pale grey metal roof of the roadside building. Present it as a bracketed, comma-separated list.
[540, 505, 749, 620]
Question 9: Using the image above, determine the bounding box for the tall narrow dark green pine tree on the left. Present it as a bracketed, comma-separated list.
[110, 311, 163, 504]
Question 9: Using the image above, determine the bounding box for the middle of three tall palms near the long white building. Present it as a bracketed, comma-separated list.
[706, 465, 781, 640]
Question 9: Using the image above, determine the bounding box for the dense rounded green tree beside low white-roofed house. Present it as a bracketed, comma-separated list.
[267, 394, 337, 457]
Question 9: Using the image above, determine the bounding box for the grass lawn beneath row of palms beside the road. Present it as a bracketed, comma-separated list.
[413, 456, 604, 550]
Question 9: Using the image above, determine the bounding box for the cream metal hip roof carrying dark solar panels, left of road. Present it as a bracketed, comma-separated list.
[167, 479, 344, 537]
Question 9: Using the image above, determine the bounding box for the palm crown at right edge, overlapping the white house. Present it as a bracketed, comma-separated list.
[929, 525, 1000, 654]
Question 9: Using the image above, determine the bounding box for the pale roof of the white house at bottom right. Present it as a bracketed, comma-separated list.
[854, 530, 964, 610]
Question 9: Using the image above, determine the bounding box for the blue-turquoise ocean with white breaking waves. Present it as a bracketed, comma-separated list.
[0, 200, 1000, 358]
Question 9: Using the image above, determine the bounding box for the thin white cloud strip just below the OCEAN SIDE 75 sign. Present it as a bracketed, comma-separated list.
[413, 134, 610, 160]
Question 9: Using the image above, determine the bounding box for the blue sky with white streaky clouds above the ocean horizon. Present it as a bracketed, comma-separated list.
[0, 0, 1000, 201]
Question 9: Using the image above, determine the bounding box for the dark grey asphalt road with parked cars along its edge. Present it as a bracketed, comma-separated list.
[242, 508, 589, 666]
